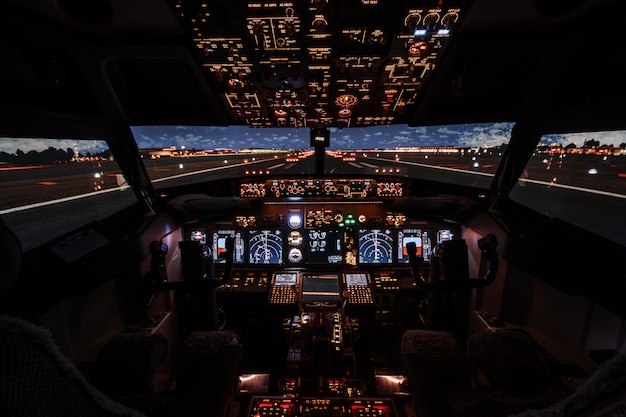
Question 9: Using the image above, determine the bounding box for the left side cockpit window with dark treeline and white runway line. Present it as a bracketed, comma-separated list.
[0, 137, 136, 251]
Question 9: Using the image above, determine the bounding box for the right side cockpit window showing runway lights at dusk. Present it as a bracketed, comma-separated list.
[510, 131, 626, 245]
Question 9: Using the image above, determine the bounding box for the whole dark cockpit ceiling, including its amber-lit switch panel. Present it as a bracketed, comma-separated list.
[0, 0, 626, 130]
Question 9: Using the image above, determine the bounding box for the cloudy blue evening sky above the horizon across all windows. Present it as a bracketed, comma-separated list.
[0, 123, 626, 153]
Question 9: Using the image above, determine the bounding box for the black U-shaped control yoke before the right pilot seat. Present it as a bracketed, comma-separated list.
[406, 234, 499, 291]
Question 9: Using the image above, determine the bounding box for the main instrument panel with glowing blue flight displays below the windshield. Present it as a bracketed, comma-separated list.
[185, 200, 460, 270]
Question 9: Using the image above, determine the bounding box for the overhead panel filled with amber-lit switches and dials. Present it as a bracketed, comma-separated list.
[172, 0, 465, 127]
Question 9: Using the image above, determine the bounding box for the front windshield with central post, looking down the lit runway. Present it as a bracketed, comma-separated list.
[132, 123, 513, 189]
